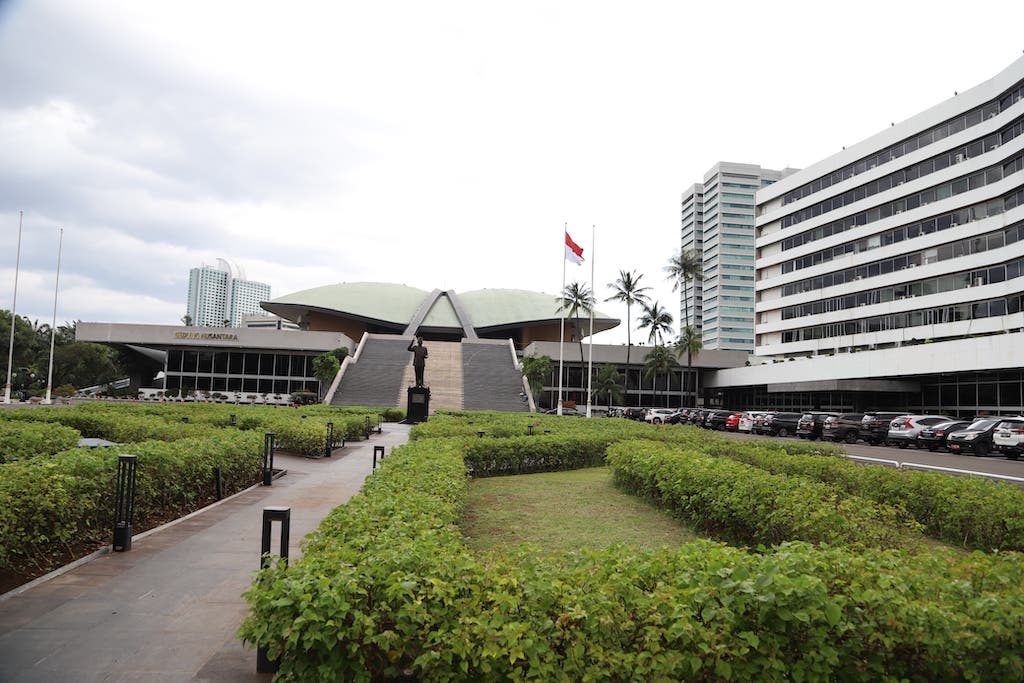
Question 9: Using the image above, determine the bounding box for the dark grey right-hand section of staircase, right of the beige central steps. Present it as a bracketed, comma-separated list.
[462, 339, 529, 413]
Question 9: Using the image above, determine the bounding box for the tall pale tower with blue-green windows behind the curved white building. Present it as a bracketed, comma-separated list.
[679, 162, 793, 352]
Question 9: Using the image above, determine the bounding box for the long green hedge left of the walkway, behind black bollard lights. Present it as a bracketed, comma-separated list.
[0, 430, 263, 573]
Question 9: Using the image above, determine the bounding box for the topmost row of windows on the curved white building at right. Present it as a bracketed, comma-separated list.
[782, 81, 1024, 206]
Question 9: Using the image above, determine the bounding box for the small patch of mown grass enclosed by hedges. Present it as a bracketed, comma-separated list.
[462, 467, 698, 554]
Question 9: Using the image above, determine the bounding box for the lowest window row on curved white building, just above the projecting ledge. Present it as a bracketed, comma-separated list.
[782, 294, 1024, 343]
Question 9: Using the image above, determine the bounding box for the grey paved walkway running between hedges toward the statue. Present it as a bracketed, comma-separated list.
[0, 424, 410, 683]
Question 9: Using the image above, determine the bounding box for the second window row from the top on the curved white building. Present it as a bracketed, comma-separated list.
[782, 117, 1024, 227]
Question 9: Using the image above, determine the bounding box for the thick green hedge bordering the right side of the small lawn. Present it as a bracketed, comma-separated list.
[607, 440, 922, 548]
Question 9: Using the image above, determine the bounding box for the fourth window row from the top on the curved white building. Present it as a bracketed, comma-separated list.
[782, 188, 1024, 273]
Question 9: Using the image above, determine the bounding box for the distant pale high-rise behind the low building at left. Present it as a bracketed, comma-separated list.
[187, 259, 270, 328]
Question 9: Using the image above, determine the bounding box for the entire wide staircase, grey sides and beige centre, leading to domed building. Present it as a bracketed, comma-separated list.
[331, 335, 529, 413]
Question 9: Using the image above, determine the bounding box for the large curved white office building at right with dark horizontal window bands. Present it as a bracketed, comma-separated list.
[705, 58, 1024, 416]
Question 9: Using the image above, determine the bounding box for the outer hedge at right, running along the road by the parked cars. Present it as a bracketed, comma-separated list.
[710, 439, 1024, 551]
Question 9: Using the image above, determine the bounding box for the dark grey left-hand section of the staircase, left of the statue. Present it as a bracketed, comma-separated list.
[331, 335, 409, 408]
